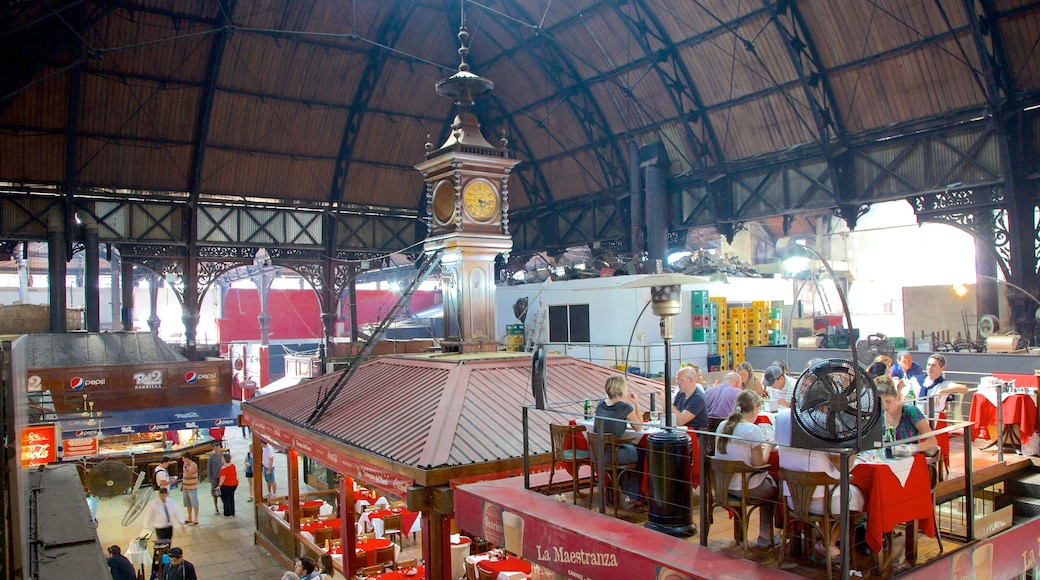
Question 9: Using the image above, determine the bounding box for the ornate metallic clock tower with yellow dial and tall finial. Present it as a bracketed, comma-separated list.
[415, 24, 519, 352]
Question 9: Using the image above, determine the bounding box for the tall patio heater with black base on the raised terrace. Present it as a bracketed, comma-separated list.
[621, 273, 705, 537]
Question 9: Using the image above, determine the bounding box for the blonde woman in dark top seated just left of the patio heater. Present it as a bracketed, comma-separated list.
[593, 374, 643, 506]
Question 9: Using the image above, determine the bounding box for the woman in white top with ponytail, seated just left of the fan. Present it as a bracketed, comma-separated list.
[714, 390, 780, 548]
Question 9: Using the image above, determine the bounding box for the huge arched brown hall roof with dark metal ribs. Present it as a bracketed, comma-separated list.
[0, 0, 1040, 254]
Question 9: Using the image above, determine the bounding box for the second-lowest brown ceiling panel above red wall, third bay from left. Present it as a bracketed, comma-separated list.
[209, 93, 347, 158]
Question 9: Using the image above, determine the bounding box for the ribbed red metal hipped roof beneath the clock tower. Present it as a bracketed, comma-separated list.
[243, 353, 661, 470]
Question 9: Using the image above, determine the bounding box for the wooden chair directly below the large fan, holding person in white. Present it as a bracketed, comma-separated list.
[778, 468, 862, 578]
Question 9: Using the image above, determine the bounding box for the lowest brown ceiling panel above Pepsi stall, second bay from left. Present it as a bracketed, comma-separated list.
[76, 136, 192, 191]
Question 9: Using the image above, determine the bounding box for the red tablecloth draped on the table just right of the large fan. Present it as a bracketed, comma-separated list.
[852, 453, 935, 552]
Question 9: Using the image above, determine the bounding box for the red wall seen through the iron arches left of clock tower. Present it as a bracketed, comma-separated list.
[216, 288, 440, 344]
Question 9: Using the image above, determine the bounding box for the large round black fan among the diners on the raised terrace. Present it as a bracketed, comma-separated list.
[790, 359, 884, 451]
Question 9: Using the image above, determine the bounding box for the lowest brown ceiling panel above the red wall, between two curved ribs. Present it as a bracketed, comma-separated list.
[202, 147, 335, 202]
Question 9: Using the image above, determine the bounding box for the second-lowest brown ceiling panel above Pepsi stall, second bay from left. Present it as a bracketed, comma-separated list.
[77, 75, 202, 143]
